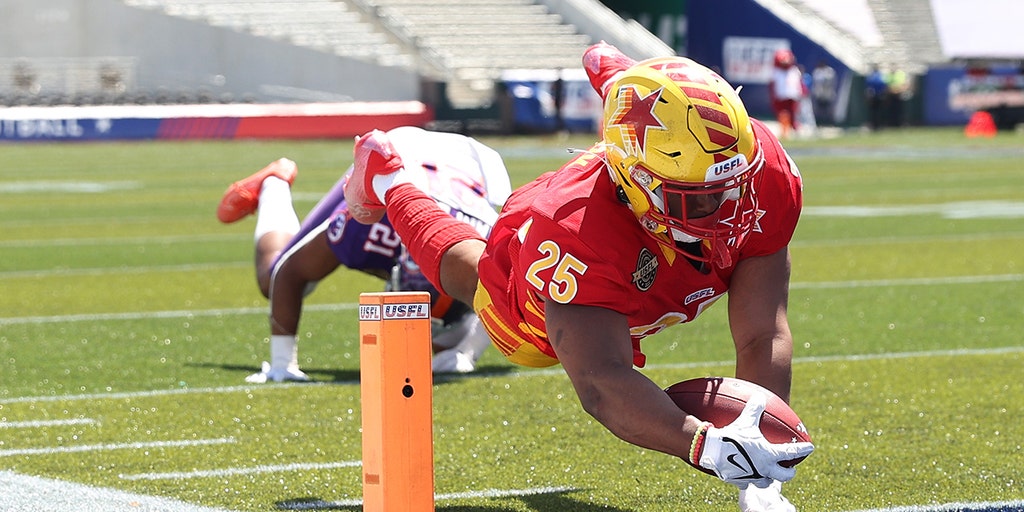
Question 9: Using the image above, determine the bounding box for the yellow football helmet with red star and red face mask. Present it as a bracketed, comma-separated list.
[604, 56, 764, 267]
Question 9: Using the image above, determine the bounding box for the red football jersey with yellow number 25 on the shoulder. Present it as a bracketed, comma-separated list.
[479, 121, 802, 367]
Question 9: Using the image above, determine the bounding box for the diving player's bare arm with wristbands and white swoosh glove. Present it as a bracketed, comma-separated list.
[545, 302, 813, 488]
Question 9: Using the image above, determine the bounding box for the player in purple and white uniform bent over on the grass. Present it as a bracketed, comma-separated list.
[217, 127, 511, 383]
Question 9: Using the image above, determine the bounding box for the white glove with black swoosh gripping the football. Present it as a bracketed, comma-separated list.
[699, 393, 814, 488]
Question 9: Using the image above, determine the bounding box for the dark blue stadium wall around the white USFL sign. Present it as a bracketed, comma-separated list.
[686, 0, 843, 119]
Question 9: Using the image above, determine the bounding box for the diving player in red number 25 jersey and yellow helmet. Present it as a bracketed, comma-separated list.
[345, 43, 814, 511]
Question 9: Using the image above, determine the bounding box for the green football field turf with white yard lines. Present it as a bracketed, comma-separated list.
[0, 129, 1024, 512]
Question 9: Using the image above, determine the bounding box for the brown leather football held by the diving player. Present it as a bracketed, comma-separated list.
[665, 377, 811, 472]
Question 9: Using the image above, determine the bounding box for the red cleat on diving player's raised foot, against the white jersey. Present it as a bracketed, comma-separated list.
[345, 130, 402, 224]
